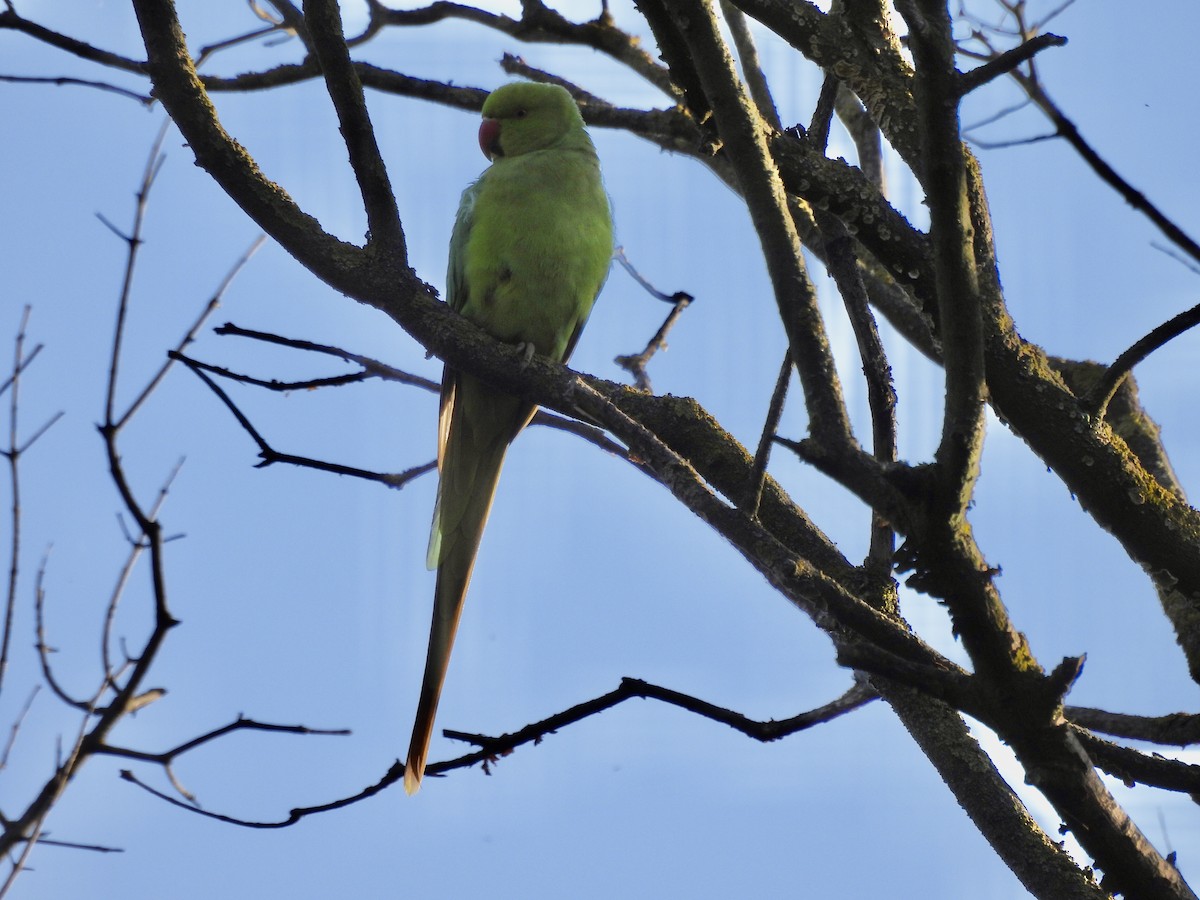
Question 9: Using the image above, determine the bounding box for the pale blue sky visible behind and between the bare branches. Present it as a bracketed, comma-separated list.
[0, 0, 1200, 900]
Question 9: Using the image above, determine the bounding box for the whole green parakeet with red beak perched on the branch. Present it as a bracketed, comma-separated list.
[404, 83, 612, 794]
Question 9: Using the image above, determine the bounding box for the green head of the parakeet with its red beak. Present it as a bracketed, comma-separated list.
[479, 82, 583, 161]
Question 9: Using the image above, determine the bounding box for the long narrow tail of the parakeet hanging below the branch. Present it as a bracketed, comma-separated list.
[404, 376, 533, 794]
